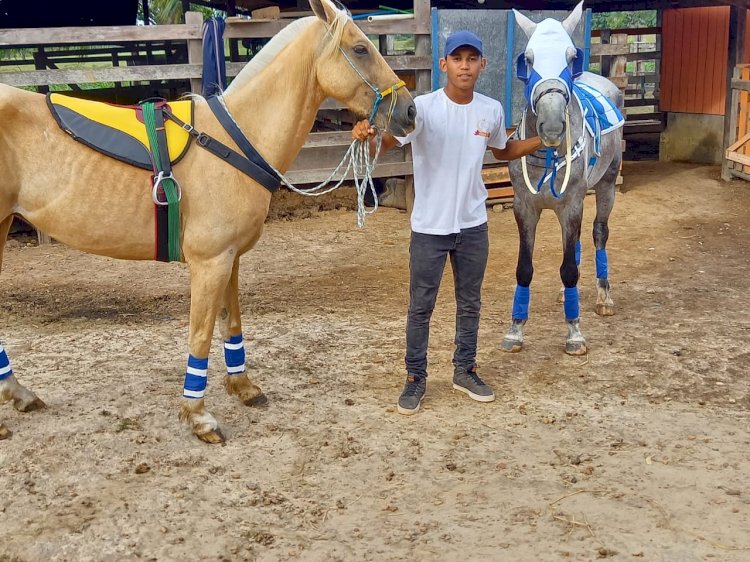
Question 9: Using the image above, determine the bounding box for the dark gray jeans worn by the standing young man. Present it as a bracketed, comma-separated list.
[406, 223, 489, 377]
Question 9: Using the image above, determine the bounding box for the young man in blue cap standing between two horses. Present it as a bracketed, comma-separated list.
[352, 31, 541, 415]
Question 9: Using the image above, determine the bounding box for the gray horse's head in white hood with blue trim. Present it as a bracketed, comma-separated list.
[513, 1, 583, 147]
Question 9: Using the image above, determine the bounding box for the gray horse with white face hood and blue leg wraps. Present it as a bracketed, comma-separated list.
[502, 2, 623, 355]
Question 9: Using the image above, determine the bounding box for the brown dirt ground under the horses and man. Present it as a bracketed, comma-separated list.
[0, 162, 750, 562]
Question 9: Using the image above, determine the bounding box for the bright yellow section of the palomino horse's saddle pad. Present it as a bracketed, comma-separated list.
[50, 93, 193, 162]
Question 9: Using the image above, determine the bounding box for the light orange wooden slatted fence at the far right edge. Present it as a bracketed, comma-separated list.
[721, 64, 750, 180]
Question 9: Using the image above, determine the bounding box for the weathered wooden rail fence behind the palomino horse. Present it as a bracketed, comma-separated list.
[0, 0, 432, 183]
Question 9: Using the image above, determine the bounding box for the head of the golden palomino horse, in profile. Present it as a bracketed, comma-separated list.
[310, 0, 417, 136]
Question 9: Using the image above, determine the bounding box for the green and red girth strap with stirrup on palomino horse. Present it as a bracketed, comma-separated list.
[141, 102, 182, 261]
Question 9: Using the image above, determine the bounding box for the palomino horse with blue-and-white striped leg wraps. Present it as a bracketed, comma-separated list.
[0, 0, 416, 443]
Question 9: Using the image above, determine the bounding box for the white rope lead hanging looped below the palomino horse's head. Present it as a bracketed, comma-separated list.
[274, 129, 383, 228]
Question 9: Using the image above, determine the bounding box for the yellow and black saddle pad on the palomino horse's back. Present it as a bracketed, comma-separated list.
[47, 93, 193, 170]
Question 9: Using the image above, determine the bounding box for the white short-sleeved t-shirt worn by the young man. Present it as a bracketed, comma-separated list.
[396, 88, 508, 234]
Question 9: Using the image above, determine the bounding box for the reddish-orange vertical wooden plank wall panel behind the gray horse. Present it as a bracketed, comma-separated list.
[660, 6, 729, 115]
